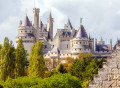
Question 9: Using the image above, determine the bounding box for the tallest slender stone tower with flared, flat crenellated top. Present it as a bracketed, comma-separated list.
[33, 8, 40, 42]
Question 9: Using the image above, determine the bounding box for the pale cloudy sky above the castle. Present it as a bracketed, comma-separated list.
[0, 0, 120, 46]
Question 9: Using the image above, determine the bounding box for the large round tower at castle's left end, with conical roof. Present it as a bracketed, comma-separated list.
[16, 16, 35, 58]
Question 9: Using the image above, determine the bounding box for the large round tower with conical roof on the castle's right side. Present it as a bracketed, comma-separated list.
[71, 25, 90, 58]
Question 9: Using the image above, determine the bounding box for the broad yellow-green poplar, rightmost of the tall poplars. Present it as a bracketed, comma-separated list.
[28, 41, 46, 77]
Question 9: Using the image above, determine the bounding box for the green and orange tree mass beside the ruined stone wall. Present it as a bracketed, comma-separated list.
[70, 53, 104, 88]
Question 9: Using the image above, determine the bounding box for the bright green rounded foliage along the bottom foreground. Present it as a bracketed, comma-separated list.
[0, 74, 81, 88]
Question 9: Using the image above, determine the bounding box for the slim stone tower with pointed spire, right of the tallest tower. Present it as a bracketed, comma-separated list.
[47, 13, 53, 40]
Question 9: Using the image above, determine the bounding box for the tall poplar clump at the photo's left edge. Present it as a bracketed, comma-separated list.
[0, 37, 15, 81]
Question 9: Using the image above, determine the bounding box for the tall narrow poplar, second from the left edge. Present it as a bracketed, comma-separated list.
[16, 39, 27, 77]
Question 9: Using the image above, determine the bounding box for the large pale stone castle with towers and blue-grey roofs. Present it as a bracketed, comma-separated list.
[16, 8, 113, 69]
